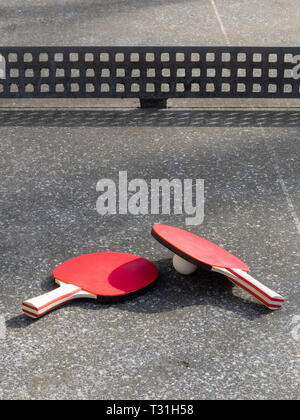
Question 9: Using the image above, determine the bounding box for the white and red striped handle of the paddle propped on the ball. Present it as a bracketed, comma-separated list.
[212, 267, 284, 310]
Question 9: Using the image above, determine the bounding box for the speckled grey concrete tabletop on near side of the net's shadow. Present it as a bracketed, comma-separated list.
[0, 122, 299, 399]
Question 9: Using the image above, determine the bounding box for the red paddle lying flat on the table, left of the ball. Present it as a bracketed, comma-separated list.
[22, 252, 158, 318]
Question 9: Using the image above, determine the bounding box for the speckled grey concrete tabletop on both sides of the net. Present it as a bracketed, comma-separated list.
[0, 0, 300, 399]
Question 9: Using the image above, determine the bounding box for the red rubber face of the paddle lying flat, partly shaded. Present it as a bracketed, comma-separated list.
[53, 252, 158, 296]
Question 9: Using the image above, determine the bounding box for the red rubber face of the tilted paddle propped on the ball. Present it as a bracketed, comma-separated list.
[152, 224, 249, 271]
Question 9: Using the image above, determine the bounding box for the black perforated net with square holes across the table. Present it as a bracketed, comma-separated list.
[0, 47, 300, 103]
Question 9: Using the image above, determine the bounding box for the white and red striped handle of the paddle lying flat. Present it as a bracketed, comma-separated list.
[22, 281, 96, 318]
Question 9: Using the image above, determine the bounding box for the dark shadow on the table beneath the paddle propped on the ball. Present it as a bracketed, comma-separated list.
[110, 259, 272, 319]
